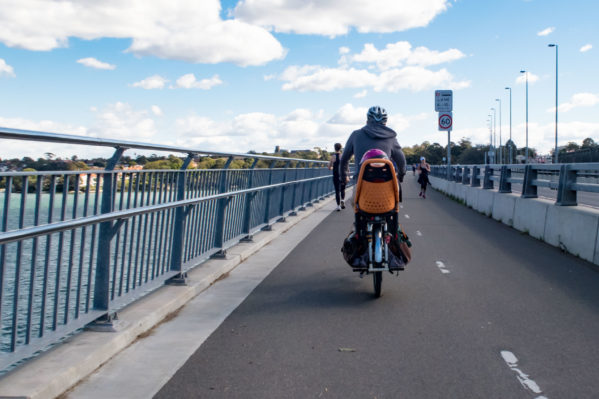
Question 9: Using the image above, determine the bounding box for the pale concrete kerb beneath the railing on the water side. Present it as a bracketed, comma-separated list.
[0, 196, 334, 398]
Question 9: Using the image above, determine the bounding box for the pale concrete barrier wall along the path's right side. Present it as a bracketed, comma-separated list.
[429, 177, 599, 265]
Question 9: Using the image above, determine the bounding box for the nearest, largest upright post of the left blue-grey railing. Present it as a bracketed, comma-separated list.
[93, 147, 126, 322]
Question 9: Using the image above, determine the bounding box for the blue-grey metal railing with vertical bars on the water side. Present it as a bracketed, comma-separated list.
[0, 128, 346, 370]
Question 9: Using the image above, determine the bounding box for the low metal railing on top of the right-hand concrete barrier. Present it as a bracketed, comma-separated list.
[431, 163, 599, 206]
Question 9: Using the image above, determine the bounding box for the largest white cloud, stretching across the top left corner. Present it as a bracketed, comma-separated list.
[0, 0, 286, 66]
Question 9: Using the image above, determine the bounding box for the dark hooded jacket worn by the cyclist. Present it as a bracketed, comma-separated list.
[339, 121, 406, 181]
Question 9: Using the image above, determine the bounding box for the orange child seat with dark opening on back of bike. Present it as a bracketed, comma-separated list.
[354, 158, 399, 214]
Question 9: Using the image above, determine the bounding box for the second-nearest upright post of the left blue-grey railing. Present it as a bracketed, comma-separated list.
[170, 154, 194, 284]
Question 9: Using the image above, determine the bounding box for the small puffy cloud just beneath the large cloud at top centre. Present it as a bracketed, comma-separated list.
[351, 41, 465, 69]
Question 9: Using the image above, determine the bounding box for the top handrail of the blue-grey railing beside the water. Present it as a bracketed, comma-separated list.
[0, 127, 328, 164]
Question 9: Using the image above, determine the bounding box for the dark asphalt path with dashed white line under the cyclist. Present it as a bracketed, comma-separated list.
[72, 175, 599, 398]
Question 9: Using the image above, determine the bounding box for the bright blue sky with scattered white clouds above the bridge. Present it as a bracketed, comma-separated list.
[0, 0, 599, 158]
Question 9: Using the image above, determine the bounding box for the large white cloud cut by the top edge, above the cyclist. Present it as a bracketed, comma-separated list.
[233, 0, 451, 37]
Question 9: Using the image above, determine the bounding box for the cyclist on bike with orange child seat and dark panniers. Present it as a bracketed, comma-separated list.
[339, 106, 409, 297]
